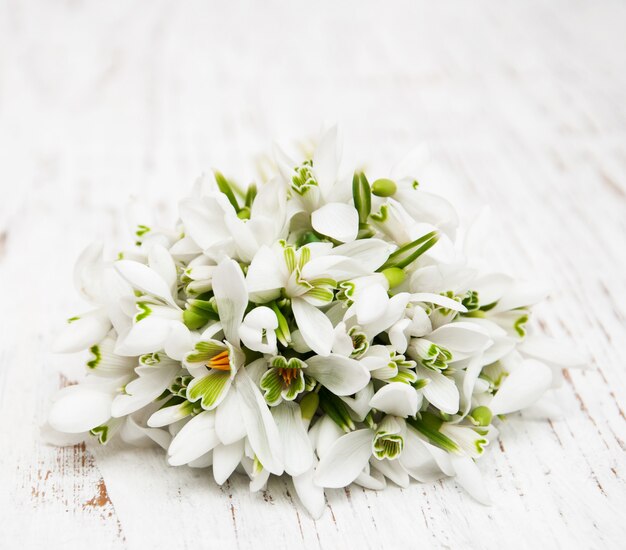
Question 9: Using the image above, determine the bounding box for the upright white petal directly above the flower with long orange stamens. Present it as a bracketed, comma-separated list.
[213, 260, 248, 345]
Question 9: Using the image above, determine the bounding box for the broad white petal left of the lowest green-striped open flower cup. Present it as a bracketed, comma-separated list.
[313, 429, 374, 488]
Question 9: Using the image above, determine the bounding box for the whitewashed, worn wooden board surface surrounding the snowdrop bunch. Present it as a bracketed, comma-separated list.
[0, 0, 626, 550]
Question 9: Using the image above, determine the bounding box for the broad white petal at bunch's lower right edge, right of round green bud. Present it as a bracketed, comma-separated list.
[489, 359, 552, 414]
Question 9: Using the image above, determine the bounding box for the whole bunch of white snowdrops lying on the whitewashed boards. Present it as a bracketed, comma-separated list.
[44, 128, 585, 517]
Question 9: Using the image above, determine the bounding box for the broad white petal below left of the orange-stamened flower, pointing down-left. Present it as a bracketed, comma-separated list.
[167, 411, 219, 466]
